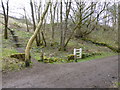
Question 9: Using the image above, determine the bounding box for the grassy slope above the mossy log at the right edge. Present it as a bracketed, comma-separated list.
[89, 30, 118, 48]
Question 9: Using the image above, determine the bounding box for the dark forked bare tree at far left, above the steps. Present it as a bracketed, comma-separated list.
[1, 0, 9, 39]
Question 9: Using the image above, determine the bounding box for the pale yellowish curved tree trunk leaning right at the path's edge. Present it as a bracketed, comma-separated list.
[25, 2, 50, 67]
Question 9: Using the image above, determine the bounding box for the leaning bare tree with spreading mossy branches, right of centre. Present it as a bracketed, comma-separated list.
[64, 2, 101, 47]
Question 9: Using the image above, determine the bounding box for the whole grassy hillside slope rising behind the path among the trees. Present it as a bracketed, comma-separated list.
[0, 13, 118, 70]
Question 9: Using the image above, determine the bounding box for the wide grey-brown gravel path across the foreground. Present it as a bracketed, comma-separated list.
[2, 56, 118, 88]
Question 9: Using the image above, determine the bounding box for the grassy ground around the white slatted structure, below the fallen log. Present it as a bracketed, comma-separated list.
[32, 35, 117, 64]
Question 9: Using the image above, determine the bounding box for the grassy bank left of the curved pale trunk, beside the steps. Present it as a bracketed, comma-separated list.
[0, 39, 24, 72]
